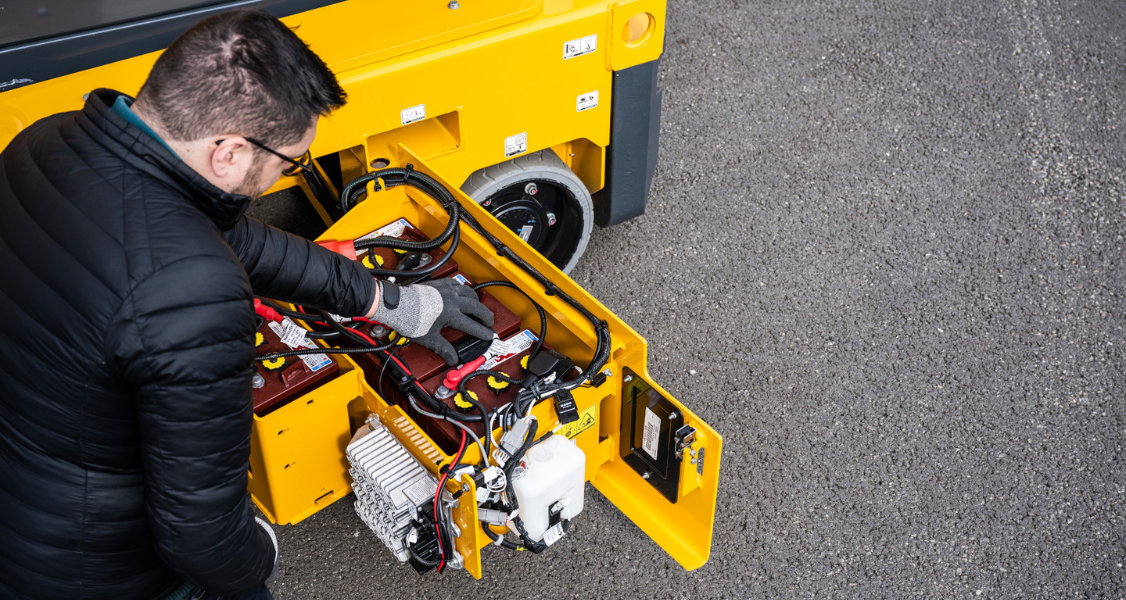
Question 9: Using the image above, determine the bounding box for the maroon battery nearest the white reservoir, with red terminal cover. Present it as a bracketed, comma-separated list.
[422, 329, 551, 454]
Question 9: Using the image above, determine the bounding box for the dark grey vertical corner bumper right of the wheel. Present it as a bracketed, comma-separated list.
[593, 59, 661, 227]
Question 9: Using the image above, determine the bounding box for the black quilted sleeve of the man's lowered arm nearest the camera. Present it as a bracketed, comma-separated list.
[106, 256, 276, 594]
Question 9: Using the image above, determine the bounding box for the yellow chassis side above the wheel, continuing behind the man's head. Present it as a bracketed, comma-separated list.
[0, 0, 664, 203]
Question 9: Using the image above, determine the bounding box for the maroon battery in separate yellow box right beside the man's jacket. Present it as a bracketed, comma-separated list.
[251, 317, 340, 417]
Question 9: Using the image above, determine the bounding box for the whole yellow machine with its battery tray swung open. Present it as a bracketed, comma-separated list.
[0, 0, 722, 577]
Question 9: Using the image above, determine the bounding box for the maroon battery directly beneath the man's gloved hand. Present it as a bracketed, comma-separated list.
[351, 272, 520, 401]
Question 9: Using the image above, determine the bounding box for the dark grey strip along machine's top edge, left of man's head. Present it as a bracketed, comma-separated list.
[0, 0, 342, 92]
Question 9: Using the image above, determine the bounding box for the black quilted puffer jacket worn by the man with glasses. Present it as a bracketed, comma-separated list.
[0, 90, 375, 600]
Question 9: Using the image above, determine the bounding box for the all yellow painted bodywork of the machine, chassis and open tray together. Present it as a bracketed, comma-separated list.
[0, 0, 723, 577]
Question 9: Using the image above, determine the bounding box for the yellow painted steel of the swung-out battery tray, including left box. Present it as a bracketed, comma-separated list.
[263, 147, 723, 577]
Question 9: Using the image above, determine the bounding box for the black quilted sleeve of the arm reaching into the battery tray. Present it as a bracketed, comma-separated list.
[225, 217, 375, 316]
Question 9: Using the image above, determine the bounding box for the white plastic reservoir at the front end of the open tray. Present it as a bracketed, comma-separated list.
[512, 435, 587, 541]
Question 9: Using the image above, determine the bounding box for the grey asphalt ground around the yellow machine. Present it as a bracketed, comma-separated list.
[248, 0, 1126, 599]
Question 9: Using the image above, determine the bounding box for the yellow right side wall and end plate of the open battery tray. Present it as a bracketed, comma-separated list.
[323, 147, 723, 568]
